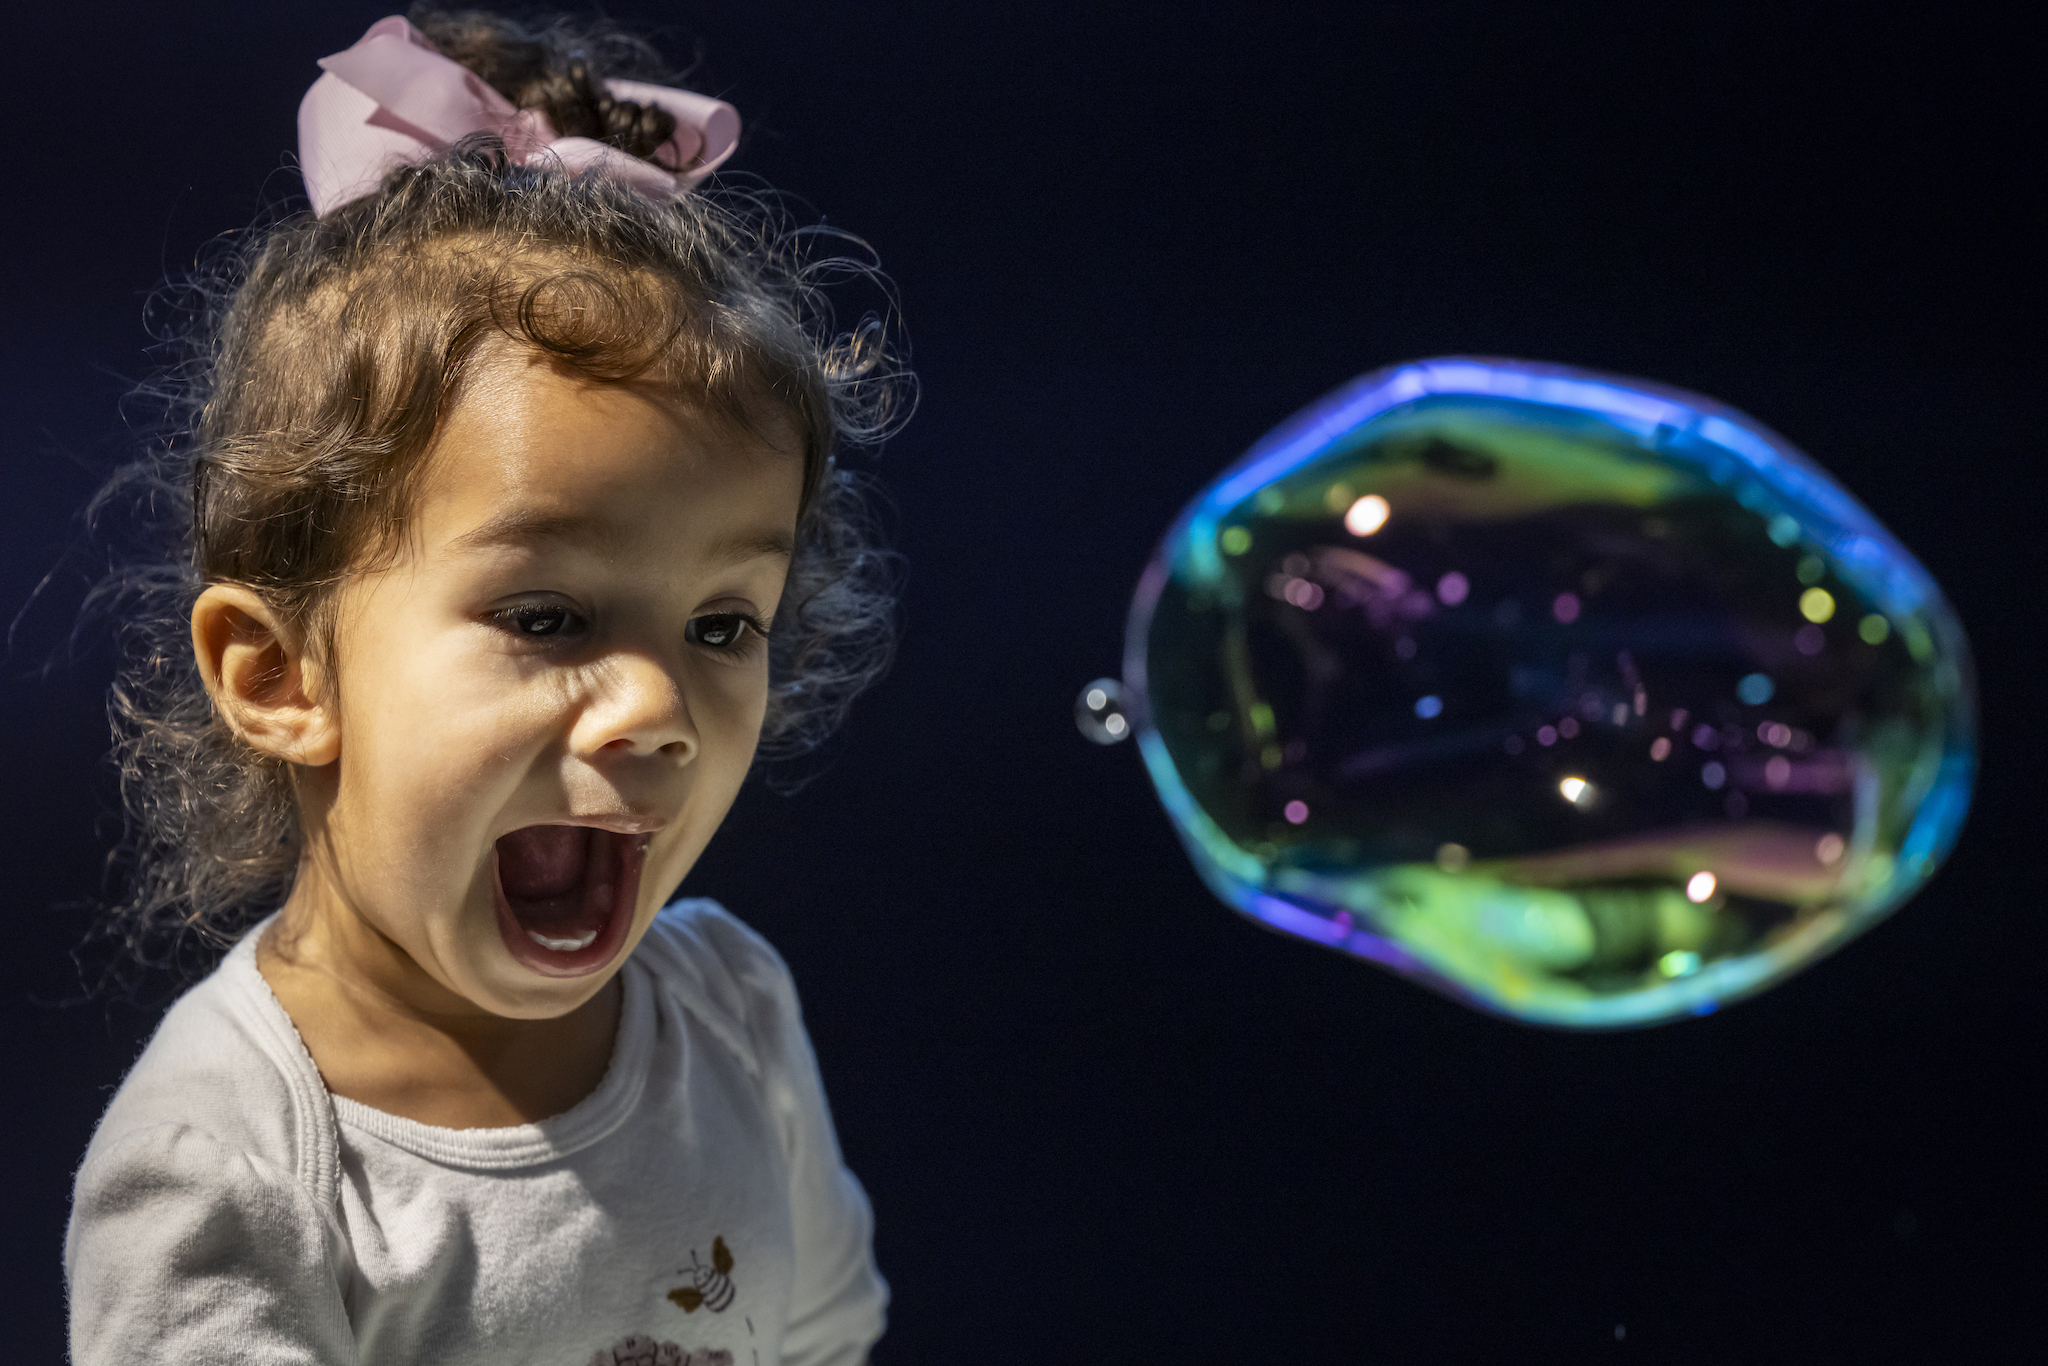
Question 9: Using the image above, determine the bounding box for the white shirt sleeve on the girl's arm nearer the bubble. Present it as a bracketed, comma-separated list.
[754, 942, 889, 1366]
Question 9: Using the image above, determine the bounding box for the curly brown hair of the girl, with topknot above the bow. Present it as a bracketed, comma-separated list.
[94, 8, 915, 965]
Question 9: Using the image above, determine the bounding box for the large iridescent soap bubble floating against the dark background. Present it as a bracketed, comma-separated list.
[1124, 358, 1974, 1026]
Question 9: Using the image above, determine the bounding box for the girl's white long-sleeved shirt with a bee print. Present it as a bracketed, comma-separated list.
[63, 901, 889, 1366]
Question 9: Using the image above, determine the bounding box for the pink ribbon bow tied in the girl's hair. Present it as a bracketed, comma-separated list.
[299, 14, 739, 215]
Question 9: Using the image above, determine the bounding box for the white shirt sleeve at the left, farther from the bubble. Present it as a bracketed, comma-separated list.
[63, 1124, 356, 1366]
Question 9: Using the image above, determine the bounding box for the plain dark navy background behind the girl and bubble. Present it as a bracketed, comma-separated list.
[0, 0, 2048, 1366]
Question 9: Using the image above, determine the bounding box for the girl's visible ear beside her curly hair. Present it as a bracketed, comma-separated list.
[193, 584, 342, 768]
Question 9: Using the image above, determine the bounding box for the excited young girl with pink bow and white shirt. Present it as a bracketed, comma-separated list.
[66, 10, 897, 1366]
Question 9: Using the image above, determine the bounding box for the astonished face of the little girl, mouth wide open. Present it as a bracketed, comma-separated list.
[293, 352, 803, 1018]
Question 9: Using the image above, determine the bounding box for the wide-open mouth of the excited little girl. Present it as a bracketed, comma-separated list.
[492, 825, 647, 977]
